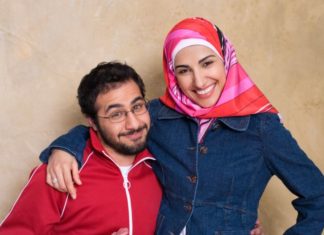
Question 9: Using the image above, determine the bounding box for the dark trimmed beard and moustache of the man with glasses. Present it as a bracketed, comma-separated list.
[97, 124, 148, 156]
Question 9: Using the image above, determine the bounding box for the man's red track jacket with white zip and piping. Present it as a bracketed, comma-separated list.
[0, 130, 162, 235]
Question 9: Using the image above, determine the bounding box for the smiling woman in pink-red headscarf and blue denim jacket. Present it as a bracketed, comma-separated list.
[42, 18, 324, 235]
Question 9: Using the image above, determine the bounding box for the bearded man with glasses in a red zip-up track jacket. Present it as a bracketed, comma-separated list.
[0, 62, 161, 235]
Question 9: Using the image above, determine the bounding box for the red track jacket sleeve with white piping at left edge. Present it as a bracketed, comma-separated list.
[0, 164, 68, 235]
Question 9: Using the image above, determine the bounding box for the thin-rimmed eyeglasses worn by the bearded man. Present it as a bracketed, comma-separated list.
[97, 100, 148, 122]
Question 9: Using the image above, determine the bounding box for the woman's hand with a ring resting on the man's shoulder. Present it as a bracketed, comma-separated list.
[46, 149, 82, 199]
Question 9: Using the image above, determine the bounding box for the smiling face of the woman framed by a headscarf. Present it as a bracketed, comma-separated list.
[174, 45, 226, 108]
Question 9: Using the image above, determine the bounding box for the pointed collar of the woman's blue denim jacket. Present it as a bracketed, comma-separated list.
[158, 105, 250, 131]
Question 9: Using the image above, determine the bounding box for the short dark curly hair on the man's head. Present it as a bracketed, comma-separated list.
[77, 61, 145, 121]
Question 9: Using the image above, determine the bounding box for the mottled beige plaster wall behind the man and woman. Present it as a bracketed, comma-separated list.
[0, 0, 324, 234]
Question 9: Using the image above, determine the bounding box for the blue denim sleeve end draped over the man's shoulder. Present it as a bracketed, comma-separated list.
[39, 125, 89, 168]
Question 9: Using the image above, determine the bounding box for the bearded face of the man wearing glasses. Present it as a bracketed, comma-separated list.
[94, 80, 150, 156]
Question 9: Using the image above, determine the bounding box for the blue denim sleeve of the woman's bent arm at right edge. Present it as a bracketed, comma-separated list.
[261, 115, 324, 235]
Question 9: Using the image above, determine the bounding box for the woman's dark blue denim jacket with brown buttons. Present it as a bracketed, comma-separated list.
[41, 100, 324, 235]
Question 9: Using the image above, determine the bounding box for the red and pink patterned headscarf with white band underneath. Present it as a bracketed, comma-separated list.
[160, 18, 278, 120]
